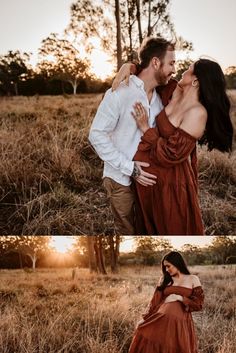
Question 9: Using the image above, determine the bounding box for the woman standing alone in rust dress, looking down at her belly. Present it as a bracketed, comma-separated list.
[129, 251, 204, 353]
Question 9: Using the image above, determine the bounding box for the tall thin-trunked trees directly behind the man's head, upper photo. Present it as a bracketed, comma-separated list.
[66, 0, 192, 73]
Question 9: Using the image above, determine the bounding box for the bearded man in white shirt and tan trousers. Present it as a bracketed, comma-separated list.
[89, 37, 175, 234]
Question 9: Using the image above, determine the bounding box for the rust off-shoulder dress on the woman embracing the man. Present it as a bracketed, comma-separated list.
[134, 83, 204, 235]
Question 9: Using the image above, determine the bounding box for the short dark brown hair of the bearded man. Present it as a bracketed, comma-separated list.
[139, 37, 175, 69]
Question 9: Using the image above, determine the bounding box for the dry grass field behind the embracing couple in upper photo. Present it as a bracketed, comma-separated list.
[0, 91, 236, 235]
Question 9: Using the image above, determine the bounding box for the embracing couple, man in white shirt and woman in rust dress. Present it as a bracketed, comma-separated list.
[89, 37, 233, 235]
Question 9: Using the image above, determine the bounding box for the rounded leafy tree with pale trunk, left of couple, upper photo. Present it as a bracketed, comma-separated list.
[38, 33, 89, 94]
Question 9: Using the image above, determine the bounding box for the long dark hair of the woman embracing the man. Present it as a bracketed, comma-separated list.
[193, 59, 233, 152]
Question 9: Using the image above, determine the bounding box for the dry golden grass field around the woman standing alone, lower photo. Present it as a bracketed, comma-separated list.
[0, 265, 236, 353]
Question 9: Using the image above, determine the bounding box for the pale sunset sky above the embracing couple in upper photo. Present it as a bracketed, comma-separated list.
[0, 0, 236, 77]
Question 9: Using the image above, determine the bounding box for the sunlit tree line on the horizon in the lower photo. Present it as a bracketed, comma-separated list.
[0, 235, 236, 275]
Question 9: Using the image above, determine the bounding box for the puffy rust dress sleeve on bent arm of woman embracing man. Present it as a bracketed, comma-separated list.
[138, 128, 196, 168]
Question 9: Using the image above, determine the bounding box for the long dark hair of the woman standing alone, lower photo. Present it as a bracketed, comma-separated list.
[157, 251, 190, 291]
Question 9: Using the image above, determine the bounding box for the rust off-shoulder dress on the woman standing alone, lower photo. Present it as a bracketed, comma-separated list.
[129, 286, 204, 353]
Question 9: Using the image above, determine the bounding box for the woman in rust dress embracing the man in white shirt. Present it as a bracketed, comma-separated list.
[113, 59, 233, 235]
